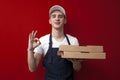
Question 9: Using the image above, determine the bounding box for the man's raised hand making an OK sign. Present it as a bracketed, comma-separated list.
[28, 31, 40, 51]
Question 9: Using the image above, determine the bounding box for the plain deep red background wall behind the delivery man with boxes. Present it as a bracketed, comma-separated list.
[0, 0, 120, 80]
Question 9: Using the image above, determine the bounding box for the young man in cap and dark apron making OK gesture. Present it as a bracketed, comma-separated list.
[28, 5, 81, 80]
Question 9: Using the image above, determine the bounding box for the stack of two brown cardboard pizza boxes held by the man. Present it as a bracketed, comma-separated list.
[57, 45, 106, 59]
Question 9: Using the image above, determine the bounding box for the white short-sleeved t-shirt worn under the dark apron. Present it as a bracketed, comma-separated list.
[34, 34, 79, 55]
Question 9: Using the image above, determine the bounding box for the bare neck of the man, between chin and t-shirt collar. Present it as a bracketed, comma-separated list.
[52, 28, 65, 41]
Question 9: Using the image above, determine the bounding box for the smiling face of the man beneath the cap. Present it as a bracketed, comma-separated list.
[49, 11, 66, 29]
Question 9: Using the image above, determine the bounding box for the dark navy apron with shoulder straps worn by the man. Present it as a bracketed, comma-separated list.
[43, 34, 73, 80]
